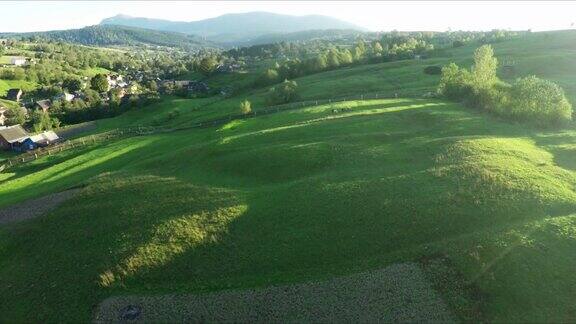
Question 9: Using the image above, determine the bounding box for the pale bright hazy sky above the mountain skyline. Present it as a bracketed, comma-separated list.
[0, 1, 576, 32]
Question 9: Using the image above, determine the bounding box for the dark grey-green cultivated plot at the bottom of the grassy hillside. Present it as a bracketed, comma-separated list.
[95, 263, 454, 323]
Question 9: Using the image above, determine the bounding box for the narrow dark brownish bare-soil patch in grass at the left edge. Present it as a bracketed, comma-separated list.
[0, 189, 80, 225]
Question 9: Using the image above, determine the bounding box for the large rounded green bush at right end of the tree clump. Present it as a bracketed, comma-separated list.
[504, 76, 572, 125]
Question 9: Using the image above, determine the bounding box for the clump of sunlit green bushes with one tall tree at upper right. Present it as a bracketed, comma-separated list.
[438, 45, 572, 126]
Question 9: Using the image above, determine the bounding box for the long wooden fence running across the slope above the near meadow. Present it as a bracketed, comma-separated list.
[0, 93, 424, 172]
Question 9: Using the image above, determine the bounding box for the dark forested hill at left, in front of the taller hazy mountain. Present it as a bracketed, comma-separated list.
[0, 25, 216, 49]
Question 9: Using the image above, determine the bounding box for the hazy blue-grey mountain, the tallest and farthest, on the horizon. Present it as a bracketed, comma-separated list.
[100, 12, 365, 43]
